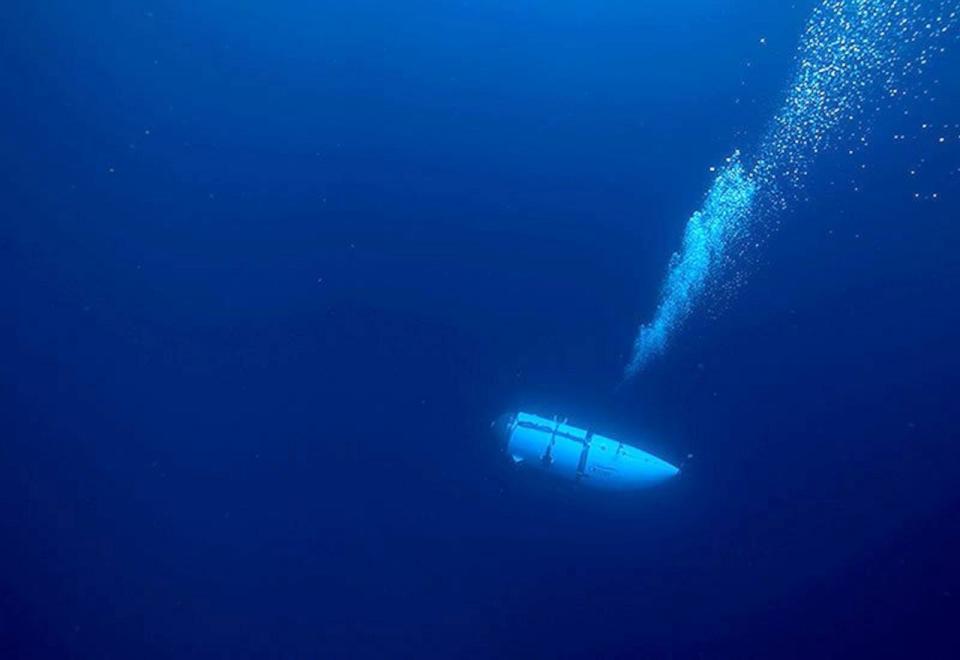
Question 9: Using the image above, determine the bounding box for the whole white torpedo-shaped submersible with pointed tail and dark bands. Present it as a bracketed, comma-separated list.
[495, 412, 680, 490]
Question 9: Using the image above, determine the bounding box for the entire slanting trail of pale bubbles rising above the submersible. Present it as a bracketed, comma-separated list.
[625, 0, 960, 380]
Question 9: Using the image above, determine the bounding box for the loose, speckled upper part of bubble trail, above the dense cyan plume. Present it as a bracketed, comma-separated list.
[751, 0, 960, 201]
